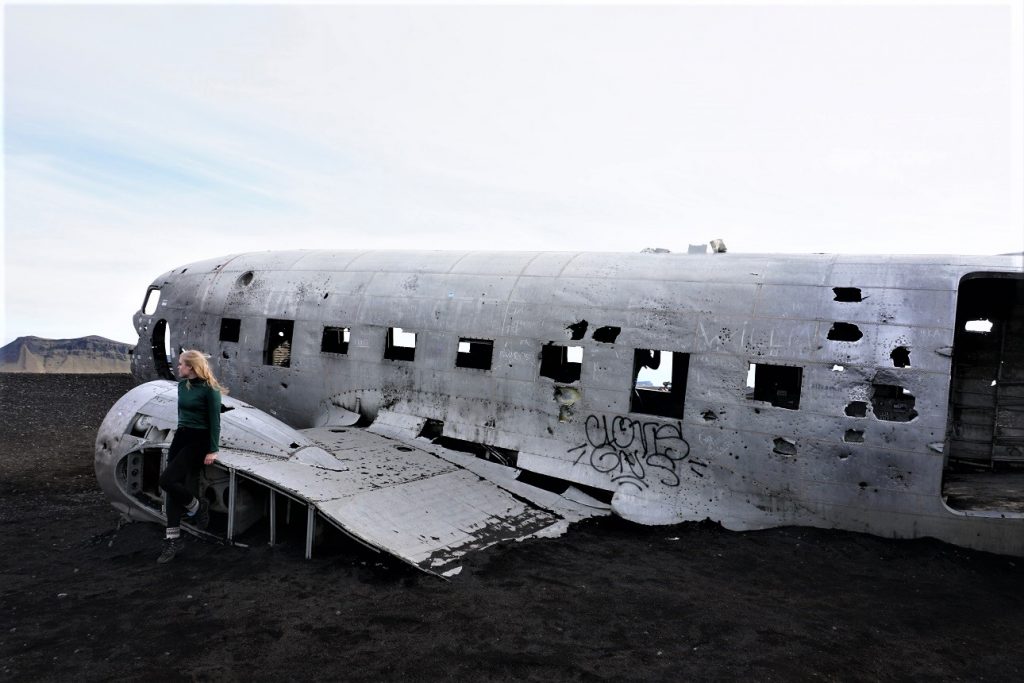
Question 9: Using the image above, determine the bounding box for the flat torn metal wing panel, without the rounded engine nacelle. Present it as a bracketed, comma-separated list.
[219, 427, 585, 574]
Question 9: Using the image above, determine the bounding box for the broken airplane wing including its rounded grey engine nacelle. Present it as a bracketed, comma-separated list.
[97, 381, 608, 575]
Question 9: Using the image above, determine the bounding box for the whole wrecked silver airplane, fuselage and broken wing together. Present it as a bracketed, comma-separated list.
[96, 251, 1024, 575]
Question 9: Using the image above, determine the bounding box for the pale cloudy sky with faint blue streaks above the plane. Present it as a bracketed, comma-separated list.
[0, 1, 1024, 343]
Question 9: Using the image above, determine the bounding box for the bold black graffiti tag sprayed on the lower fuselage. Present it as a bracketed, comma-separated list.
[568, 415, 708, 489]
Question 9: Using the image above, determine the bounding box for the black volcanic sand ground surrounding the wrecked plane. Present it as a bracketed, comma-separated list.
[0, 375, 1024, 681]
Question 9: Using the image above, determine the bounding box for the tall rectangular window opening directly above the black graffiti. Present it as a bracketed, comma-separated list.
[630, 348, 690, 418]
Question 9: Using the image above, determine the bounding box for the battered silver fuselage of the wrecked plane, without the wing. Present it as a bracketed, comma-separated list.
[101, 251, 1024, 554]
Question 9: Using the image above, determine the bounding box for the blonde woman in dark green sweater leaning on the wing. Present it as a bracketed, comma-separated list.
[157, 350, 227, 564]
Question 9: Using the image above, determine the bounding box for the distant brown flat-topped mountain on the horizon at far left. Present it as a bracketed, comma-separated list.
[0, 336, 134, 374]
